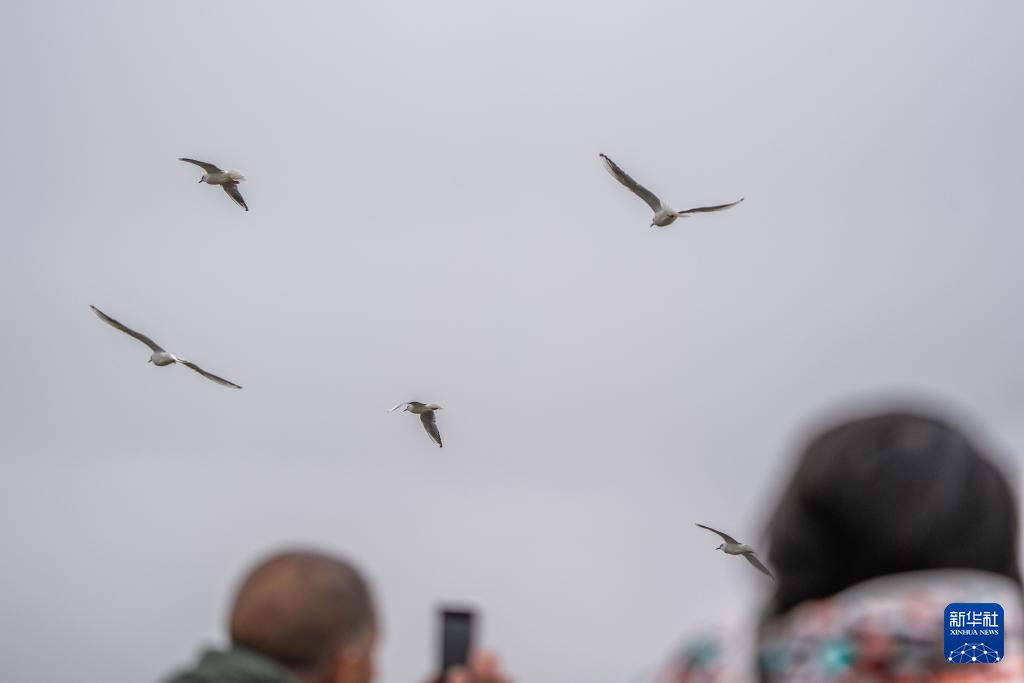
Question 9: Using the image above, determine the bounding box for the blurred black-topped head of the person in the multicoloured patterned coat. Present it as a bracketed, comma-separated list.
[768, 413, 1021, 614]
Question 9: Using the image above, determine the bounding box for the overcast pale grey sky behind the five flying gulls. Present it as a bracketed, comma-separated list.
[0, 0, 1024, 683]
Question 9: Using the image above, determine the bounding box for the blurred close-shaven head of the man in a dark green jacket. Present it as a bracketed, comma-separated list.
[229, 551, 377, 683]
